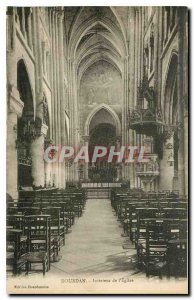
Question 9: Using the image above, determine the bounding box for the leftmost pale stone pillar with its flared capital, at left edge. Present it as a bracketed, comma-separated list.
[6, 86, 24, 199]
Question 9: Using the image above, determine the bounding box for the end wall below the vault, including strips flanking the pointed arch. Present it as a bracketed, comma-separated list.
[78, 61, 123, 133]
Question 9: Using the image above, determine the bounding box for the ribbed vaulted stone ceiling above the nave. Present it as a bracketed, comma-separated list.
[65, 6, 131, 80]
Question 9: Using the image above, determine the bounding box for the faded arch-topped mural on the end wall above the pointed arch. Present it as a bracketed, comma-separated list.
[80, 61, 122, 105]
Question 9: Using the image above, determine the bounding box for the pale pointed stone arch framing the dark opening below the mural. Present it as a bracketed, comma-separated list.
[84, 103, 121, 136]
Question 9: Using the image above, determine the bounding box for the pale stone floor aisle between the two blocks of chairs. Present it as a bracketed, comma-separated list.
[48, 199, 136, 278]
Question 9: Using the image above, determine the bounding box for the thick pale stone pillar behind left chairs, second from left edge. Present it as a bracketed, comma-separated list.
[31, 124, 48, 187]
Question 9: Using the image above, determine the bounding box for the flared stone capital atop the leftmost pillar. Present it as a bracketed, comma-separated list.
[8, 85, 24, 118]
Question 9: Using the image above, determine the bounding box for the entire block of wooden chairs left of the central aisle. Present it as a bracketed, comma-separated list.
[7, 190, 86, 275]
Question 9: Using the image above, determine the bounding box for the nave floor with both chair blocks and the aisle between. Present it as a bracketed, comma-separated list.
[7, 188, 187, 280]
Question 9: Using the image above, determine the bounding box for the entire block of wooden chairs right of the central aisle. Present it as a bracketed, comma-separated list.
[111, 189, 188, 276]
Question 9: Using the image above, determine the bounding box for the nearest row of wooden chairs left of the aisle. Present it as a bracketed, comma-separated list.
[7, 215, 52, 275]
